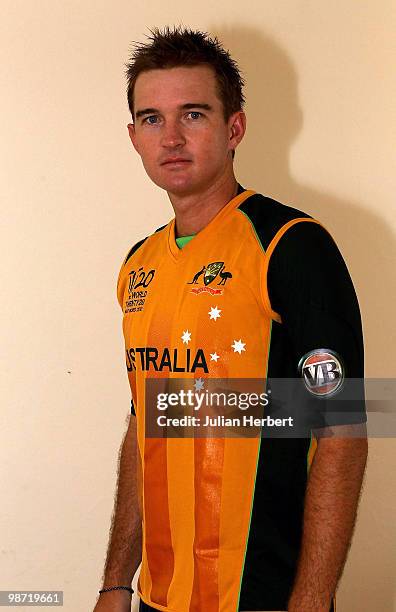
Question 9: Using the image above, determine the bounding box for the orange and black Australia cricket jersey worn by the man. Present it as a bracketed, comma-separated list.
[118, 188, 362, 612]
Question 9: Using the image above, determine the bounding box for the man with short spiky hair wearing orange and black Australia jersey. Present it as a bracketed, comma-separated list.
[95, 28, 367, 612]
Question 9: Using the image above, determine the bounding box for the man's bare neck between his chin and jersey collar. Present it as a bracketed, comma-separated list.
[168, 175, 238, 237]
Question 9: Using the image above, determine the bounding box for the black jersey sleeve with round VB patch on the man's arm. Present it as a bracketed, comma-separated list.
[267, 221, 366, 426]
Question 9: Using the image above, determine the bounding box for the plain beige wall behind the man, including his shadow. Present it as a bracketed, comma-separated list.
[0, 0, 396, 612]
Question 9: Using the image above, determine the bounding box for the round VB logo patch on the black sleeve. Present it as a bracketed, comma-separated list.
[298, 349, 345, 397]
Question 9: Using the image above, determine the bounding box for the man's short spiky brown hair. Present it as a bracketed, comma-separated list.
[125, 26, 245, 121]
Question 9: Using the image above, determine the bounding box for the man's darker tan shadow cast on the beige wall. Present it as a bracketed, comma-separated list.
[208, 26, 396, 612]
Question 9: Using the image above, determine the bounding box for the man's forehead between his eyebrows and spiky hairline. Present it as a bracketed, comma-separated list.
[134, 66, 221, 111]
